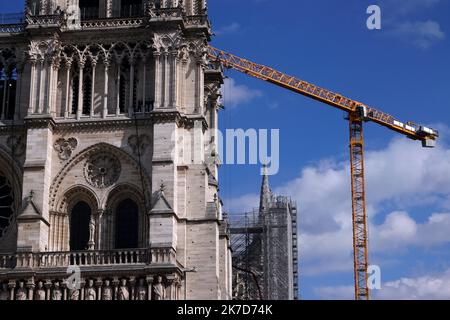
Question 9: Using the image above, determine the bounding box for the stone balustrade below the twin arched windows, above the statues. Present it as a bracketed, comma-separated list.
[0, 248, 177, 270]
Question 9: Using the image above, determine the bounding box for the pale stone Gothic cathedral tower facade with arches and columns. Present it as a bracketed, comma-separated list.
[0, 0, 231, 300]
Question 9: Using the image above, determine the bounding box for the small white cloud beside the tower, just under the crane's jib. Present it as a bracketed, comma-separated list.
[222, 78, 262, 108]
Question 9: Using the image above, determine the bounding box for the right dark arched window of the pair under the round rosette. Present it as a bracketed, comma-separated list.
[115, 199, 139, 249]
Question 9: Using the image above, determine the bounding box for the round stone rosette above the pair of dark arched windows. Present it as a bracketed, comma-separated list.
[84, 153, 122, 189]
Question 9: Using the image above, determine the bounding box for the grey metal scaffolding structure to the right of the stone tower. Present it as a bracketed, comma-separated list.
[229, 195, 298, 300]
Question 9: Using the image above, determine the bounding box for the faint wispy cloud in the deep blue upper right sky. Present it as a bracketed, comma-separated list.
[392, 20, 445, 49]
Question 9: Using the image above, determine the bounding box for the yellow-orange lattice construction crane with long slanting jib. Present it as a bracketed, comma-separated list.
[208, 47, 439, 300]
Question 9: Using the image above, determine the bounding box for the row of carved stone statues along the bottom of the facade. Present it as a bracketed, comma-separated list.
[0, 273, 184, 301]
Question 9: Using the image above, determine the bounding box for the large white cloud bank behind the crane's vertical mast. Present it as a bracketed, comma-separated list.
[225, 128, 450, 276]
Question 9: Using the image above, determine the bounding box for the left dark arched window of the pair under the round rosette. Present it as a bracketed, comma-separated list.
[70, 201, 91, 251]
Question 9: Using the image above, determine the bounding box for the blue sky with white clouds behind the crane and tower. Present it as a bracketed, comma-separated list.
[0, 0, 450, 299]
